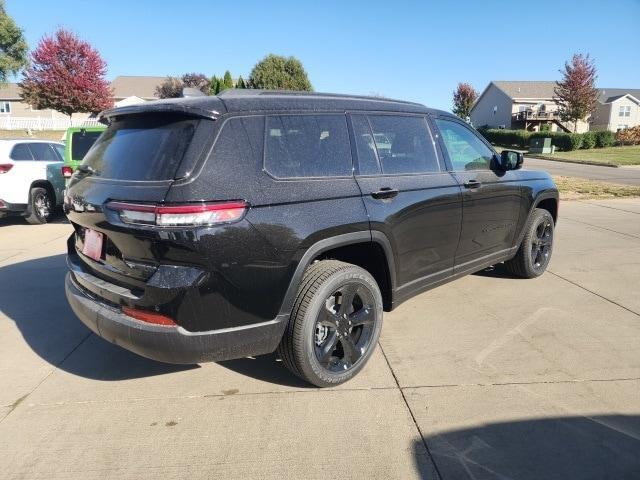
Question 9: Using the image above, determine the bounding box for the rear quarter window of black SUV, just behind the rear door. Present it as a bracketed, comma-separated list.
[264, 115, 352, 178]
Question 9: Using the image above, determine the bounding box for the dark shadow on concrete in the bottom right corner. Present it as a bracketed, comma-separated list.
[413, 415, 640, 480]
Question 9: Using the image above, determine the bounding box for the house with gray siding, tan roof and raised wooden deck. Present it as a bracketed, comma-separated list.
[470, 80, 589, 132]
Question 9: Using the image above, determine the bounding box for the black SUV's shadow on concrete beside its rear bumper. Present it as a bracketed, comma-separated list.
[0, 253, 198, 381]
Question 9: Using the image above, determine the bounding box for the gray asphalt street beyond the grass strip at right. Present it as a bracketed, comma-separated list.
[524, 156, 640, 186]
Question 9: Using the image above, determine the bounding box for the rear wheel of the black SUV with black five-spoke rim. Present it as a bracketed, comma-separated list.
[278, 260, 382, 387]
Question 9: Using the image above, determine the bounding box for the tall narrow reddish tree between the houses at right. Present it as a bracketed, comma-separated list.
[554, 54, 598, 132]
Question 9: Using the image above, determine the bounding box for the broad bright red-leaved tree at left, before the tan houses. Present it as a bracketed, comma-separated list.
[19, 29, 113, 120]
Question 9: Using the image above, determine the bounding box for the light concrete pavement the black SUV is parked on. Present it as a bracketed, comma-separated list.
[0, 200, 640, 479]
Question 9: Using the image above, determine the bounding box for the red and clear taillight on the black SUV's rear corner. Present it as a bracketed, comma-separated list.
[107, 201, 249, 227]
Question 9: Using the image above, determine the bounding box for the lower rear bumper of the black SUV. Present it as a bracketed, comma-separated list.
[65, 272, 288, 364]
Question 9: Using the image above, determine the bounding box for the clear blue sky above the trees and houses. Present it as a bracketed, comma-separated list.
[6, 0, 640, 110]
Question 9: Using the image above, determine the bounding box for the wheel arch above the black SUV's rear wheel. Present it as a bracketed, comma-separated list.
[280, 230, 395, 314]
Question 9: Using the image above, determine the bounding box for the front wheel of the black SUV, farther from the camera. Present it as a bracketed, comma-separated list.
[504, 208, 554, 278]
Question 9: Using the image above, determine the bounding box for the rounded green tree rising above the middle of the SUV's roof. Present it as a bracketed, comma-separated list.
[249, 54, 313, 92]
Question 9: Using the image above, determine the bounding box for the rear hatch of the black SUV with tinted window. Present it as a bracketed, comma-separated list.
[65, 112, 215, 289]
